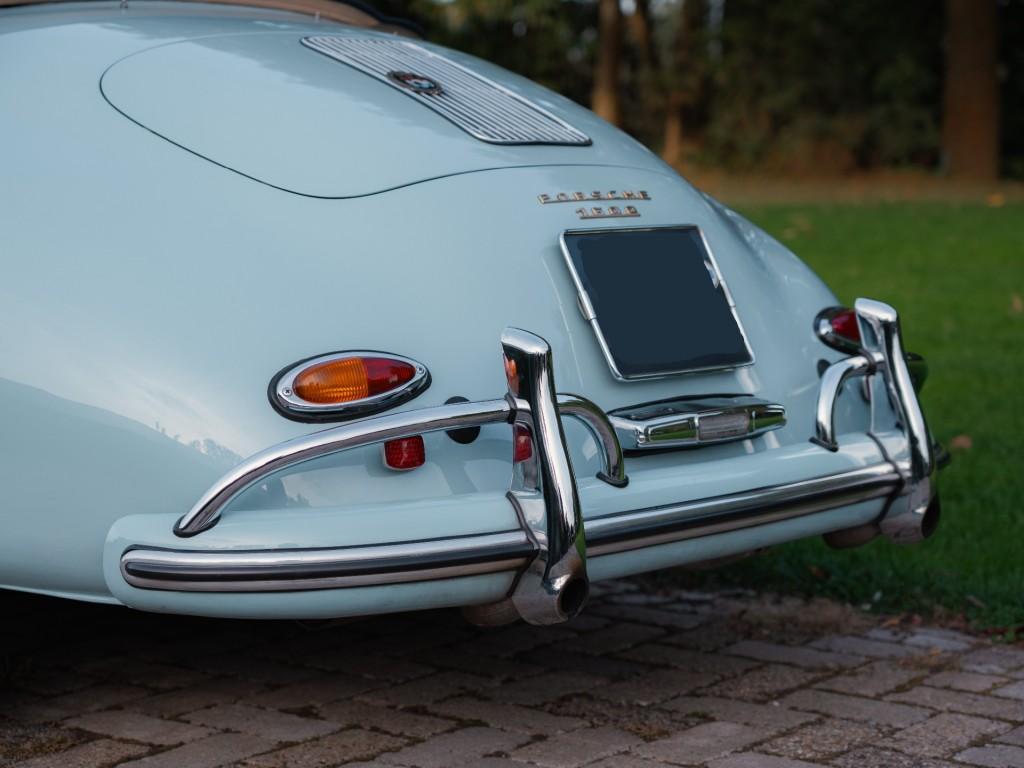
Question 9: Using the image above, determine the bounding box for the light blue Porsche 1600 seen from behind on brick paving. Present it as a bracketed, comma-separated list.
[0, 0, 939, 625]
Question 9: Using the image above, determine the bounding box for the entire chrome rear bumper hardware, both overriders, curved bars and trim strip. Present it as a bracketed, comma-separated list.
[121, 300, 934, 624]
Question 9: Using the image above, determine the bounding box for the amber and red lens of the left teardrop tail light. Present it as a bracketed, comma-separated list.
[292, 357, 416, 404]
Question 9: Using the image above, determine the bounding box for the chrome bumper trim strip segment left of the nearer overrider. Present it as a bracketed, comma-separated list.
[121, 530, 536, 592]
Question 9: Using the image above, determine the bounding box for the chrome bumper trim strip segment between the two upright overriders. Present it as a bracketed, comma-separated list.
[587, 462, 900, 557]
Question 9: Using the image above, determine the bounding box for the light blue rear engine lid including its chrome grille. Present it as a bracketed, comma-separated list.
[100, 28, 659, 198]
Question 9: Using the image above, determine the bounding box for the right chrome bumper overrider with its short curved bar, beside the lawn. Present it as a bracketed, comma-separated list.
[811, 299, 939, 544]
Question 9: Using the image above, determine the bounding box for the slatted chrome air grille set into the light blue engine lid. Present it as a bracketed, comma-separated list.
[302, 35, 590, 145]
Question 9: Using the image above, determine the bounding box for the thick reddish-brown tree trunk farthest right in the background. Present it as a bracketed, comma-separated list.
[942, 0, 999, 181]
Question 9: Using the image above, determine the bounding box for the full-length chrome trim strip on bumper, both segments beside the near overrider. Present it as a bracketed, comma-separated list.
[121, 462, 901, 593]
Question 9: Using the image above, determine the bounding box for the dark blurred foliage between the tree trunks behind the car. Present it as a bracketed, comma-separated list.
[377, 0, 1024, 176]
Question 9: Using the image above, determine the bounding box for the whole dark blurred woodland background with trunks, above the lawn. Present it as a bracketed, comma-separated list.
[375, 0, 1024, 180]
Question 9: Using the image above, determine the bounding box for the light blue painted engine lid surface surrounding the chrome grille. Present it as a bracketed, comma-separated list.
[101, 29, 659, 198]
